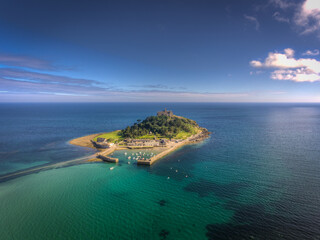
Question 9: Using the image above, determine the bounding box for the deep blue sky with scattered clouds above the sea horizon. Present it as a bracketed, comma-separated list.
[0, 0, 320, 102]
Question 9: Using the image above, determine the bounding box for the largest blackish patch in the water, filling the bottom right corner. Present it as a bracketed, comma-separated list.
[206, 204, 320, 240]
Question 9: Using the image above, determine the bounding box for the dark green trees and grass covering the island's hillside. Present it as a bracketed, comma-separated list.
[119, 116, 199, 139]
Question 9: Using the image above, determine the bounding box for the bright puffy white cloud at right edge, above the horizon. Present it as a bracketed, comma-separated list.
[250, 48, 320, 82]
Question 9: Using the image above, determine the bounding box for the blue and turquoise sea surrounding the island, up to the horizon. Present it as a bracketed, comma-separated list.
[0, 103, 320, 240]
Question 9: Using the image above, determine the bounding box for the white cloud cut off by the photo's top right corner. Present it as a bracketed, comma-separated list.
[294, 0, 320, 34]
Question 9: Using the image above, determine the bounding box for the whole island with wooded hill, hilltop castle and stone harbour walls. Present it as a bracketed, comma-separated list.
[70, 109, 210, 165]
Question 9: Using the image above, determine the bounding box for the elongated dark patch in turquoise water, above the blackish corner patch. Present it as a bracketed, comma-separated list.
[184, 179, 246, 198]
